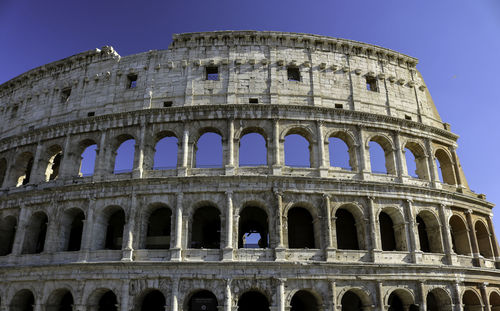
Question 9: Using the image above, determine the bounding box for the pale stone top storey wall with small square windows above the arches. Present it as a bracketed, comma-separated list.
[0, 31, 444, 137]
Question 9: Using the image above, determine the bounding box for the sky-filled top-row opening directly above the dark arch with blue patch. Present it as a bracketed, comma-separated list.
[239, 133, 267, 166]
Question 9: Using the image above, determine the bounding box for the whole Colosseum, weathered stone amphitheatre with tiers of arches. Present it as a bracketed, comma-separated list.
[0, 31, 500, 311]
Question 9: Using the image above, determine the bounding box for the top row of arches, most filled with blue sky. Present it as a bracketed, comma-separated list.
[0, 127, 457, 186]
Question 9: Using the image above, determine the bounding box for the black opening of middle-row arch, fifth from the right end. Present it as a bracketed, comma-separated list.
[335, 208, 359, 250]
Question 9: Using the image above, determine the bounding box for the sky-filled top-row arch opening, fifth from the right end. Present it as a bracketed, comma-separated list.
[284, 132, 312, 167]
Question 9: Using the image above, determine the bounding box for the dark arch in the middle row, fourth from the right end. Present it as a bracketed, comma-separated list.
[378, 207, 408, 251]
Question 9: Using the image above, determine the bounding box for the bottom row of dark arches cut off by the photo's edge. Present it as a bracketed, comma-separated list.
[4, 287, 500, 311]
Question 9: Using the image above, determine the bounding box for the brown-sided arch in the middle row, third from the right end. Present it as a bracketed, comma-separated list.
[416, 210, 443, 253]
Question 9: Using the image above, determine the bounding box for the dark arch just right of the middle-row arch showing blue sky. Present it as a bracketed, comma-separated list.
[284, 202, 320, 249]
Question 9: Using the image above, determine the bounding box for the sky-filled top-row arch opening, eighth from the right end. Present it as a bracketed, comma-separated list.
[153, 133, 179, 170]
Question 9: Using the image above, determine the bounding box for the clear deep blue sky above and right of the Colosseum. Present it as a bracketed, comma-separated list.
[0, 0, 500, 238]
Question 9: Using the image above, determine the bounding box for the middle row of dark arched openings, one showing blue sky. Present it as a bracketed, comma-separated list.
[0, 202, 495, 258]
